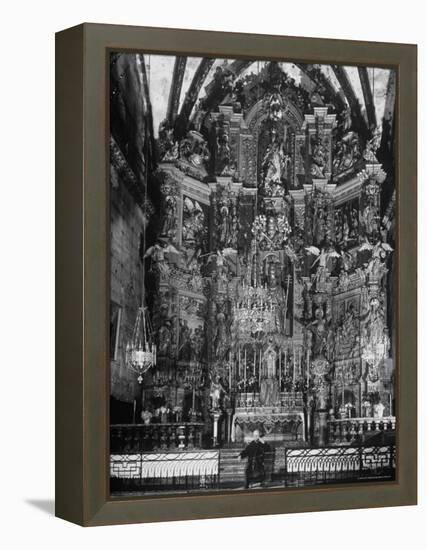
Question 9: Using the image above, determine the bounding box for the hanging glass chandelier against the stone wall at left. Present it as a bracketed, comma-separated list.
[126, 307, 156, 384]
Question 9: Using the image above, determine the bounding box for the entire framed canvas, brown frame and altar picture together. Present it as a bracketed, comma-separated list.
[57, 25, 416, 525]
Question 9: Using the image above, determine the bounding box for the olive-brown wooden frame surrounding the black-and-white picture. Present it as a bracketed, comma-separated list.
[56, 24, 417, 526]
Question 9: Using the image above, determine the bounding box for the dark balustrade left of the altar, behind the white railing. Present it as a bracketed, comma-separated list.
[110, 422, 203, 453]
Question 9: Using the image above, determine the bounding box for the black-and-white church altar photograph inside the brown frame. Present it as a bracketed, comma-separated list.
[108, 51, 399, 497]
